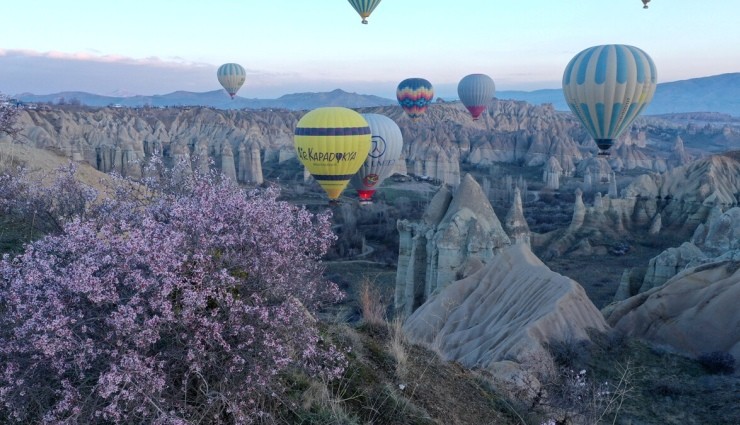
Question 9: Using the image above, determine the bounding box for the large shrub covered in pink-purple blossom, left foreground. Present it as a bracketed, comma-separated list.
[0, 167, 345, 424]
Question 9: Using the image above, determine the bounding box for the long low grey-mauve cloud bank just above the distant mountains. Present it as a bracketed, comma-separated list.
[0, 49, 557, 99]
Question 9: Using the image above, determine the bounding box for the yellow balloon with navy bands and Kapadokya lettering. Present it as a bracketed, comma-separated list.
[294, 107, 371, 200]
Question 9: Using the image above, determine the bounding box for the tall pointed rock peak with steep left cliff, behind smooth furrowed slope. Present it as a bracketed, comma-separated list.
[395, 174, 511, 315]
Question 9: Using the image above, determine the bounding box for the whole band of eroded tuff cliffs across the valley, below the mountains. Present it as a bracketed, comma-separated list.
[14, 100, 740, 186]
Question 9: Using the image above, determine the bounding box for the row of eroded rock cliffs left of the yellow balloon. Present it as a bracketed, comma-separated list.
[19, 108, 302, 184]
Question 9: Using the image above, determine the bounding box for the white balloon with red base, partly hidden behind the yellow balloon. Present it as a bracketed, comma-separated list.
[350, 114, 403, 202]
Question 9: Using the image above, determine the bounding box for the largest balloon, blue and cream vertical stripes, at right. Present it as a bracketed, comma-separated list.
[563, 44, 657, 155]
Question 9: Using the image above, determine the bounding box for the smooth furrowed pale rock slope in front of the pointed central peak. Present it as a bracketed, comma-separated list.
[404, 244, 608, 368]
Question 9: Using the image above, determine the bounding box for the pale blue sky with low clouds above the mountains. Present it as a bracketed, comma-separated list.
[0, 0, 740, 98]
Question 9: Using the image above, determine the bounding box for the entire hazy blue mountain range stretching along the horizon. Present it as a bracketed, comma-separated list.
[15, 72, 740, 117]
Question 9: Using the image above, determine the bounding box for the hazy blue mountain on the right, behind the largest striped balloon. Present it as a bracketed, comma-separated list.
[496, 72, 740, 117]
